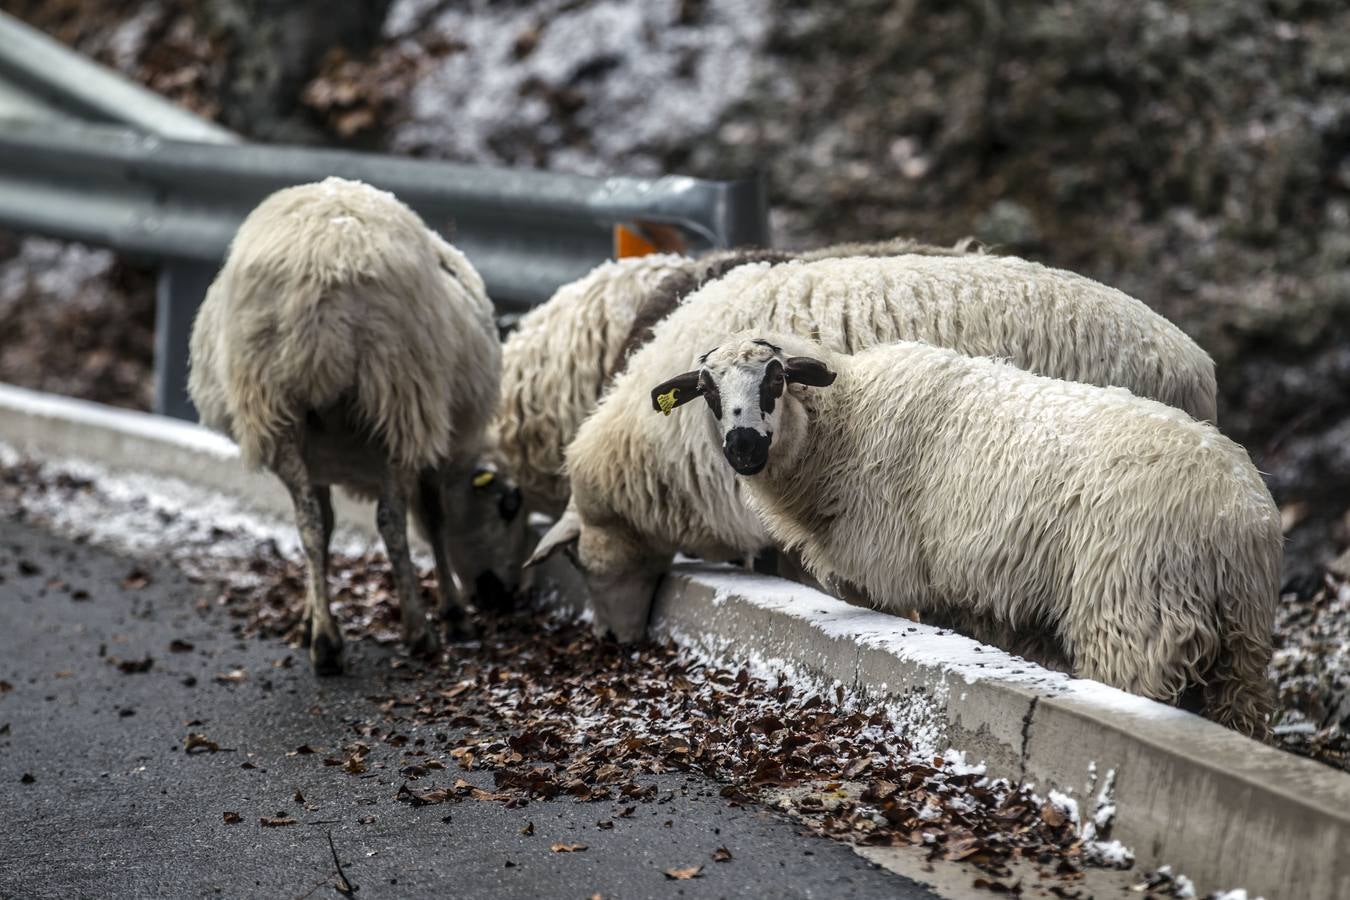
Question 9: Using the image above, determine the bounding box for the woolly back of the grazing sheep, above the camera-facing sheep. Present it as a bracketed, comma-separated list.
[653, 254, 1216, 421]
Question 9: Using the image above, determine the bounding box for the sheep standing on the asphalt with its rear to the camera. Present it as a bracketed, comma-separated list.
[188, 178, 527, 675]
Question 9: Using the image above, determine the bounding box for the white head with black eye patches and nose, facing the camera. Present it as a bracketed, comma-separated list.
[652, 337, 834, 475]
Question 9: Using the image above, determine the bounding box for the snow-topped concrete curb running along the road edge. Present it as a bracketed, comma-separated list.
[0, 385, 1350, 900]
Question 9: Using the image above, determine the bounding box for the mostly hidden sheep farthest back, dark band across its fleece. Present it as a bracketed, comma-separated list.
[491, 239, 965, 517]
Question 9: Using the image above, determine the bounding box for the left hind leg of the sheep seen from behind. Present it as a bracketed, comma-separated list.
[275, 440, 342, 675]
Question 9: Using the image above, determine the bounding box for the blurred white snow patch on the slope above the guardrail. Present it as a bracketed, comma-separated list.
[385, 0, 772, 174]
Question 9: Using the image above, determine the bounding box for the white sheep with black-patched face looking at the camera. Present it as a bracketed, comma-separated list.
[652, 332, 1283, 735]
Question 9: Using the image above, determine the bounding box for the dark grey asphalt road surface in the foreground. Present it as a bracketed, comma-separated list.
[0, 519, 936, 900]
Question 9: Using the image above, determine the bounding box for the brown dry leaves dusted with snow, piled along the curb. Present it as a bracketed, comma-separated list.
[202, 548, 1129, 896]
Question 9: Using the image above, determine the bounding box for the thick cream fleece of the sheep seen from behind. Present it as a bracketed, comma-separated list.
[189, 178, 501, 470]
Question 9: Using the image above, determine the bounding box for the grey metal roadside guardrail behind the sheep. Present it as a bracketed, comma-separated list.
[0, 15, 768, 418]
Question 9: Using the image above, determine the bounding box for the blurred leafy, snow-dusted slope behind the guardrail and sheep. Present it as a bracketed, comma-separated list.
[5, 0, 1350, 568]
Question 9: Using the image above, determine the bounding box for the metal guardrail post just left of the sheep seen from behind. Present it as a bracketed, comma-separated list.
[155, 259, 216, 422]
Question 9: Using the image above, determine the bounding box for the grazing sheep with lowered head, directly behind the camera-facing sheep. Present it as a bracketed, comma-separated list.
[531, 255, 1215, 641]
